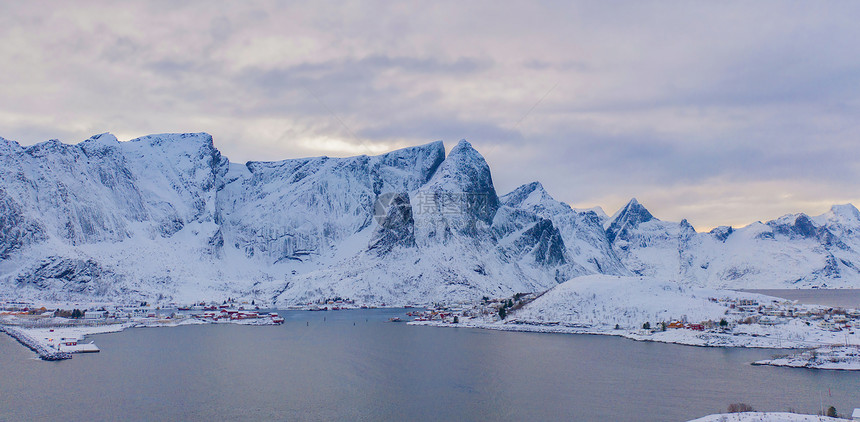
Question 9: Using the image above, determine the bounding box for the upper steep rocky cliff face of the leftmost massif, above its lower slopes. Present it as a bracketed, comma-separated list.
[0, 134, 221, 249]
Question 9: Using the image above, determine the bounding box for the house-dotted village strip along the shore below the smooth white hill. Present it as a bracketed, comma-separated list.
[409, 294, 860, 369]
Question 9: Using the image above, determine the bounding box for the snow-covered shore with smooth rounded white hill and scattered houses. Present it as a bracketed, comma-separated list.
[412, 275, 860, 349]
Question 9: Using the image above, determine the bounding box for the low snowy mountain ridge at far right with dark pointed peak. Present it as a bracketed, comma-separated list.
[606, 199, 860, 289]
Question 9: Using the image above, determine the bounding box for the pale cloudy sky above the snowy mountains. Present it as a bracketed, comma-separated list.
[0, 0, 860, 230]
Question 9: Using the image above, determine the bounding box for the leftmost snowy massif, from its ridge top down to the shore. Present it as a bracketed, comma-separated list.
[0, 134, 235, 300]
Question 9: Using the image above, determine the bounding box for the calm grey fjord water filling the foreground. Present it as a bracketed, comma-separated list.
[0, 310, 860, 421]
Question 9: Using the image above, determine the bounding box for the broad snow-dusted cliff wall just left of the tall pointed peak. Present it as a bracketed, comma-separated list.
[219, 142, 445, 264]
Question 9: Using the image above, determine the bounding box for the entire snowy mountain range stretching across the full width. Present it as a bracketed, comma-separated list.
[0, 133, 860, 305]
